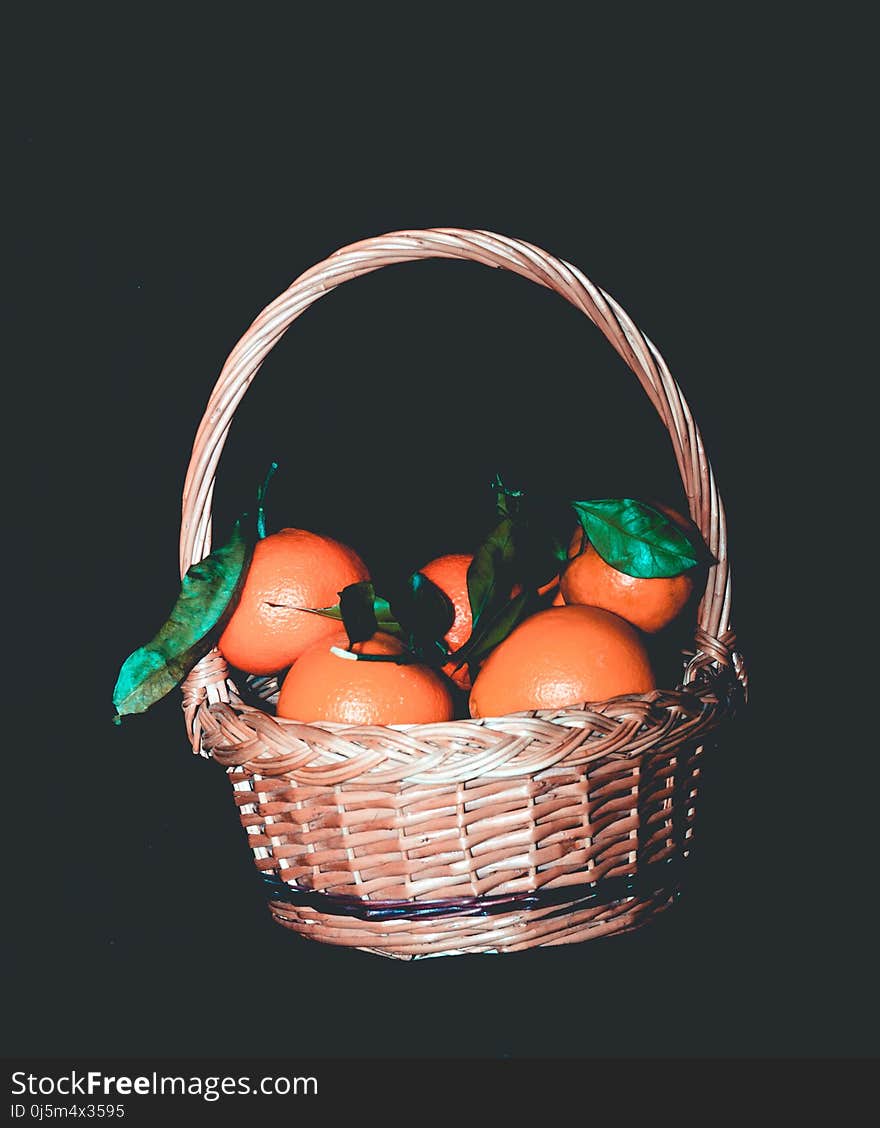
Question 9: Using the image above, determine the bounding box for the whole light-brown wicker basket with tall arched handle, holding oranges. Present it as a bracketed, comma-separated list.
[174, 228, 746, 959]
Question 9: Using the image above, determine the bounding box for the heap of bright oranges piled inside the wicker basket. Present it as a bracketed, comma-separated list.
[218, 505, 695, 725]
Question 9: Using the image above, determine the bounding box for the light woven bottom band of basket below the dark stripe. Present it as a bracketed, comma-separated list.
[269, 889, 677, 960]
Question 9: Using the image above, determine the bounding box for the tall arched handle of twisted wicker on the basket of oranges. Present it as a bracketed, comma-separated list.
[181, 228, 745, 735]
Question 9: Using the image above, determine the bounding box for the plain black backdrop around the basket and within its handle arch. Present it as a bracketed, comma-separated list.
[5, 6, 878, 1082]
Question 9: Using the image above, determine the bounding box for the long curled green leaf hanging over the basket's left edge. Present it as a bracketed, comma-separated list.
[113, 520, 253, 716]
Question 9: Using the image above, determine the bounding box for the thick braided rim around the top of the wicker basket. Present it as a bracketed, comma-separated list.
[192, 663, 745, 786]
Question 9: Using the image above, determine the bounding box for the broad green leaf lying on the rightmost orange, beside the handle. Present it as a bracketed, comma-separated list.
[572, 497, 705, 579]
